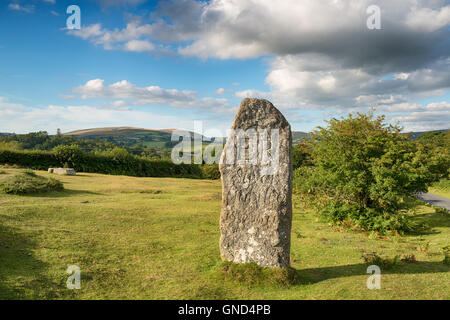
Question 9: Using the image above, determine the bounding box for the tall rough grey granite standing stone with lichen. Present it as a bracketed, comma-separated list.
[219, 98, 292, 268]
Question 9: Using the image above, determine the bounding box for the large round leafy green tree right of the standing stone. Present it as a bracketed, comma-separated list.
[303, 112, 437, 231]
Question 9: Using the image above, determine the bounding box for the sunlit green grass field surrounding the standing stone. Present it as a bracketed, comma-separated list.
[0, 168, 450, 299]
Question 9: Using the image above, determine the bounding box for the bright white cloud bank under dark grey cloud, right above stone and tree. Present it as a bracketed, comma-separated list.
[266, 54, 450, 108]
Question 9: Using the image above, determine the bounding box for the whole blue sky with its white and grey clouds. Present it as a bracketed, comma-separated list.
[0, 0, 450, 133]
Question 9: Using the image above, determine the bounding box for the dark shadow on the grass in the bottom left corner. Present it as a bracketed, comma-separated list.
[0, 220, 59, 300]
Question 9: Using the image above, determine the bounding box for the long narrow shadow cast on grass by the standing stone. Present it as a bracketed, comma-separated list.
[297, 261, 450, 285]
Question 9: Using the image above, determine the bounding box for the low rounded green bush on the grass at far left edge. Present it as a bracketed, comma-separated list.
[0, 170, 64, 195]
